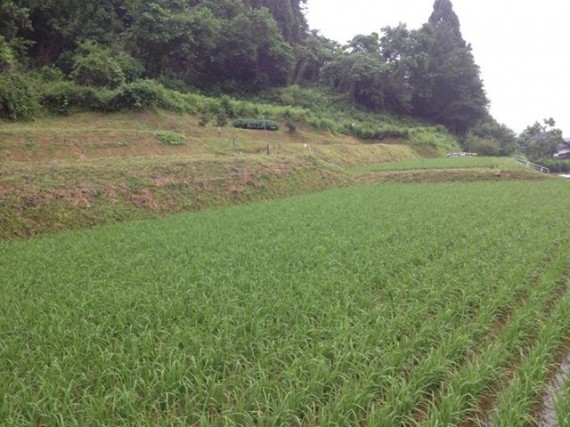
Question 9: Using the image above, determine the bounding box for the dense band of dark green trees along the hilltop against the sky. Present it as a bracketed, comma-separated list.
[0, 0, 488, 137]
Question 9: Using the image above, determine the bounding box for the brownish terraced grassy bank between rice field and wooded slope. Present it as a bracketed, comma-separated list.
[0, 111, 536, 239]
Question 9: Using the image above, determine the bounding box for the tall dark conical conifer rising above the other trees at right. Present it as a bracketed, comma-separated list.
[412, 0, 488, 133]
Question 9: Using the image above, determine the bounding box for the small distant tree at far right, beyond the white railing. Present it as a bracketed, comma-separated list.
[518, 118, 564, 161]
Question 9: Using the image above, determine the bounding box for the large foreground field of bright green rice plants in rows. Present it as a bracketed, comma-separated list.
[0, 179, 570, 426]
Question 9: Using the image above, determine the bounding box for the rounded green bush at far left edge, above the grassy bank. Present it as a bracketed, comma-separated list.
[0, 73, 40, 120]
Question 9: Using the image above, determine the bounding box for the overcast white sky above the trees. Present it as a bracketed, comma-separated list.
[307, 0, 570, 137]
